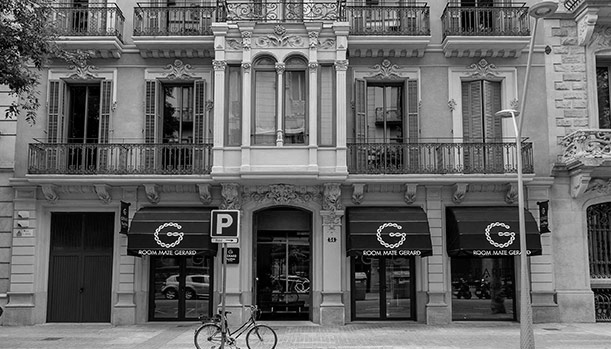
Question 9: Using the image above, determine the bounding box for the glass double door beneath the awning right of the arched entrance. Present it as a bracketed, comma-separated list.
[352, 256, 416, 320]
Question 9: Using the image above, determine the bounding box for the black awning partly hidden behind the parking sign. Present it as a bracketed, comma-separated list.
[127, 207, 217, 256]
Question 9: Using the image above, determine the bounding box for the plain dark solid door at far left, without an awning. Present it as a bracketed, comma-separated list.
[47, 212, 115, 322]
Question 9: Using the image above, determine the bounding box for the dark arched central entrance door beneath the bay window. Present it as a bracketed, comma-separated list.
[255, 209, 311, 320]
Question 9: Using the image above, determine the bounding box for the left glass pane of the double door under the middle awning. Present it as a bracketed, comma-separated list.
[352, 256, 382, 318]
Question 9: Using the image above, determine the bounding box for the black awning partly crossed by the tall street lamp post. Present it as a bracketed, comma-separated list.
[446, 206, 541, 257]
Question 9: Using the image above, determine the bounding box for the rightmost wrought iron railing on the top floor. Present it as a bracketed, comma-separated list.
[441, 3, 530, 39]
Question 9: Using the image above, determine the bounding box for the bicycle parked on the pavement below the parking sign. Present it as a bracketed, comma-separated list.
[193, 305, 278, 349]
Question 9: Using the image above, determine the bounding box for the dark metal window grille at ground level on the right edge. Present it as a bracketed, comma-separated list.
[587, 202, 611, 279]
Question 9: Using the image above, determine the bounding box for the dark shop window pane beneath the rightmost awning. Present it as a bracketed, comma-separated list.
[452, 257, 516, 320]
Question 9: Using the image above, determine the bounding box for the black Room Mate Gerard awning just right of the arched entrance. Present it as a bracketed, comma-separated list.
[346, 207, 433, 256]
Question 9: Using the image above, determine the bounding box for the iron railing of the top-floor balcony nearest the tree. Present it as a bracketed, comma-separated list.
[51, 3, 125, 41]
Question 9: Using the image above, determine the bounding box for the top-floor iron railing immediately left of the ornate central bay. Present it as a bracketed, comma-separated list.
[134, 3, 221, 36]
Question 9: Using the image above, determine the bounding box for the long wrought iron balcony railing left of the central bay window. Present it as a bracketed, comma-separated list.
[28, 143, 212, 175]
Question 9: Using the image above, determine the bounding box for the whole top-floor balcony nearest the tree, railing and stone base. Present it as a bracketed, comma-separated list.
[51, 3, 125, 58]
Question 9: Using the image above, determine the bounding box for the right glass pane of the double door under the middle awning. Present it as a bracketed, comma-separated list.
[386, 257, 412, 318]
